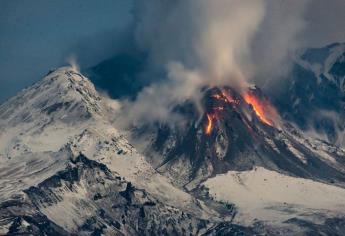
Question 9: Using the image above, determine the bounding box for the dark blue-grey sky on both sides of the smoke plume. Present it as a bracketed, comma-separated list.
[0, 0, 345, 103]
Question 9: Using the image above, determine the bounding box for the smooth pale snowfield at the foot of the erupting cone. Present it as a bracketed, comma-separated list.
[204, 167, 345, 224]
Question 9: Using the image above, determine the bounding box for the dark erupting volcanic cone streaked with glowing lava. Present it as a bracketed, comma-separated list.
[134, 87, 345, 188]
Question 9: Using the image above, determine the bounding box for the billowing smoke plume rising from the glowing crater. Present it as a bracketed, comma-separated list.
[119, 0, 305, 126]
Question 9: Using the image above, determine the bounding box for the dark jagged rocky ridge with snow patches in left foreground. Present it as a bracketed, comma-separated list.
[0, 155, 209, 235]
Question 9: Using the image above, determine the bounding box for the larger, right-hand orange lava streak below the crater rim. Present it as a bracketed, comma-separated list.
[243, 93, 274, 126]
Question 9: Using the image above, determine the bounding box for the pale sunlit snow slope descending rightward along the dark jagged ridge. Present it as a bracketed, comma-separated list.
[68, 127, 216, 215]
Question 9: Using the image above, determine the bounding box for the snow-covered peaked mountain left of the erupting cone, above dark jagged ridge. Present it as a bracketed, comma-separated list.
[0, 68, 194, 205]
